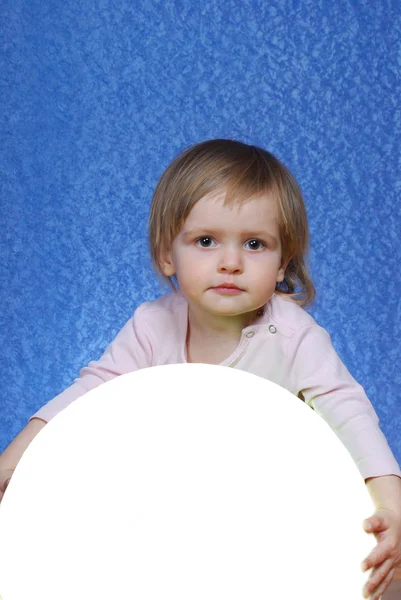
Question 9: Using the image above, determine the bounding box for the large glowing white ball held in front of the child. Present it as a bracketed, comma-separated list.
[0, 364, 374, 600]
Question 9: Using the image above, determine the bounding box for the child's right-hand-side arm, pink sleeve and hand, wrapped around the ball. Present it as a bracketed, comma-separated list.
[286, 327, 401, 600]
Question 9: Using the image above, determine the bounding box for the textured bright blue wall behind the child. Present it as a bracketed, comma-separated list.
[0, 0, 401, 462]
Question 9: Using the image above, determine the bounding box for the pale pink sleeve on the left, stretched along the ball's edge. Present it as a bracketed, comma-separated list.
[31, 307, 152, 422]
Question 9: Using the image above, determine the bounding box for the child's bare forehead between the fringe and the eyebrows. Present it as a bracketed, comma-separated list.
[183, 191, 278, 231]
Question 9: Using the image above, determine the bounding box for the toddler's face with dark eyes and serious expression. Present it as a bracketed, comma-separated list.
[161, 191, 286, 316]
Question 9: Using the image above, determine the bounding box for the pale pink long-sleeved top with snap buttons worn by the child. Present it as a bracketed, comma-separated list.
[32, 293, 401, 479]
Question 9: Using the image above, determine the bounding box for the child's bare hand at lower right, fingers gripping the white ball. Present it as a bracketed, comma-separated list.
[362, 508, 401, 600]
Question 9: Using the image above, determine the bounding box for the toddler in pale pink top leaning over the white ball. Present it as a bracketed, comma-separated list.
[0, 140, 401, 600]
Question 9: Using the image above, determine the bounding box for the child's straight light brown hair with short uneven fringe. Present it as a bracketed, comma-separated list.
[149, 140, 315, 306]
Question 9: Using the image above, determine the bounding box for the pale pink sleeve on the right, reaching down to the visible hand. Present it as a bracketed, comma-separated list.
[288, 324, 401, 479]
